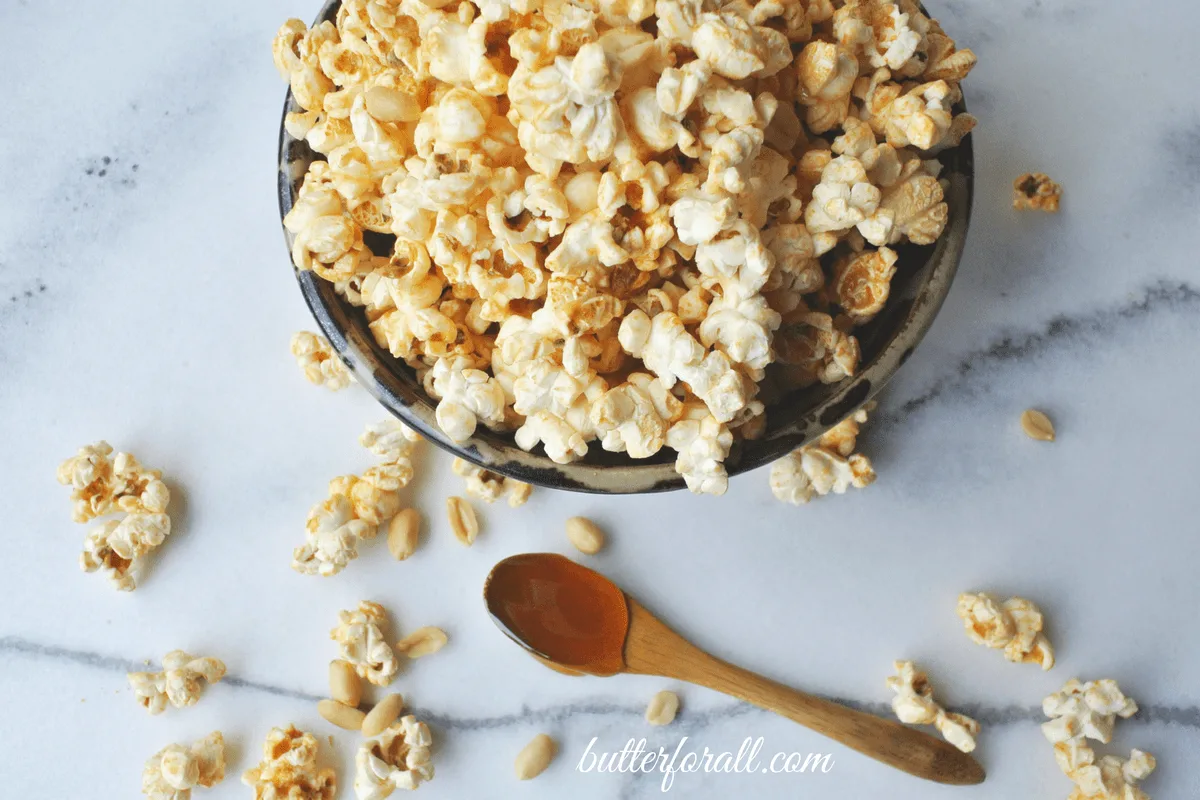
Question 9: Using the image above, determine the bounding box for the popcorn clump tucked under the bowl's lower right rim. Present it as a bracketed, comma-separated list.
[770, 403, 875, 505]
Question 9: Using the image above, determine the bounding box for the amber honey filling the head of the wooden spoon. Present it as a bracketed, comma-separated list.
[484, 553, 629, 675]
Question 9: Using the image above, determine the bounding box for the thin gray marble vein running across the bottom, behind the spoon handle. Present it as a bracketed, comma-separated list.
[0, 636, 1200, 733]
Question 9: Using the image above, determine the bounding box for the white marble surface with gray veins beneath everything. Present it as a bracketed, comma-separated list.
[0, 0, 1200, 800]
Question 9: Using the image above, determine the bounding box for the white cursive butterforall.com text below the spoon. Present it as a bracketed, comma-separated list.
[575, 736, 834, 792]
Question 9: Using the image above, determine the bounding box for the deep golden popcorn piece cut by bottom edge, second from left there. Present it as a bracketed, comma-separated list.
[241, 724, 337, 800]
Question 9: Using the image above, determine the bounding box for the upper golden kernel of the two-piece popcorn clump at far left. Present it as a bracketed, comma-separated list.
[58, 441, 170, 522]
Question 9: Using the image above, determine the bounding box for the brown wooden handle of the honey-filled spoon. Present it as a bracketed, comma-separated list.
[625, 597, 984, 786]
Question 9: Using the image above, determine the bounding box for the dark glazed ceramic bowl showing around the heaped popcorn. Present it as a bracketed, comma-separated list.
[277, 0, 974, 494]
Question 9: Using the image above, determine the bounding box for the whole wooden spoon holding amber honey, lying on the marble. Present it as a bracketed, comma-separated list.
[484, 553, 984, 786]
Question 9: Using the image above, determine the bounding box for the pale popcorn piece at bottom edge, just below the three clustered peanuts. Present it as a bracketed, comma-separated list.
[354, 715, 433, 800]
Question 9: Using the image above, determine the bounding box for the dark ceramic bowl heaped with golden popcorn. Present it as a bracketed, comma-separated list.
[272, 0, 976, 494]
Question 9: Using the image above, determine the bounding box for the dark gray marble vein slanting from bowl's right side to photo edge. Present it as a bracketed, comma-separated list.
[878, 280, 1200, 425]
